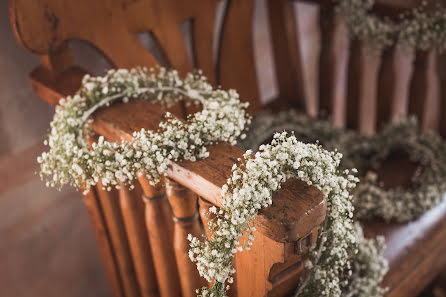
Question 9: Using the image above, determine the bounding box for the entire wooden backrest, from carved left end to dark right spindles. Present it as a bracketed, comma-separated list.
[11, 0, 446, 135]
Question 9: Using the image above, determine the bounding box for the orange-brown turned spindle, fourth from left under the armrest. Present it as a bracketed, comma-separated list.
[139, 177, 181, 297]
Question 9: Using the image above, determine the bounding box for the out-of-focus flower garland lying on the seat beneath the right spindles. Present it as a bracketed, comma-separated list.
[239, 111, 446, 222]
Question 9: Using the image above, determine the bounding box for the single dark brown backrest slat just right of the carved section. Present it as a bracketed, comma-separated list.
[267, 0, 308, 112]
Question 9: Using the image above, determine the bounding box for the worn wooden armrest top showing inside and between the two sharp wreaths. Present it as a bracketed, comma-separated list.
[92, 100, 326, 242]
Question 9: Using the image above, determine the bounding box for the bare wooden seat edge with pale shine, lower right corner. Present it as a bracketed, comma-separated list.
[364, 197, 446, 297]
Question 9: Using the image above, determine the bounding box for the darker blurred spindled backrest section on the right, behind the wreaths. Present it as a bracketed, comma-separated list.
[268, 0, 446, 136]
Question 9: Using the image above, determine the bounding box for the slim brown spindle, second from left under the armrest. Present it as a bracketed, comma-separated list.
[97, 185, 141, 297]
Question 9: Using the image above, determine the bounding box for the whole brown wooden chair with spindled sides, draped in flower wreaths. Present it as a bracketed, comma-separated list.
[10, 0, 446, 297]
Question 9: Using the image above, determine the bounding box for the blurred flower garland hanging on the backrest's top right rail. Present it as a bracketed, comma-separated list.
[336, 0, 446, 52]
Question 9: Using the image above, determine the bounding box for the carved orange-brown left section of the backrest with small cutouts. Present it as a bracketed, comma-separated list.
[10, 0, 259, 111]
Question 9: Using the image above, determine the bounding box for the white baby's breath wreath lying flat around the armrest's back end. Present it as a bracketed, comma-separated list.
[38, 68, 250, 191]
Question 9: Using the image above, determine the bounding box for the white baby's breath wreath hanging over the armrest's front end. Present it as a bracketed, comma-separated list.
[189, 132, 386, 297]
